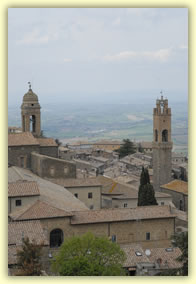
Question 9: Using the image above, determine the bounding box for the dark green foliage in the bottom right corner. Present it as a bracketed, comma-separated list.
[157, 232, 188, 276]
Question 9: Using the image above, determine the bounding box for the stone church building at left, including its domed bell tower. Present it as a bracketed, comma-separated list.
[8, 83, 76, 178]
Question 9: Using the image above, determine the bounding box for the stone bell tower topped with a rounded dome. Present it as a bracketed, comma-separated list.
[21, 82, 41, 137]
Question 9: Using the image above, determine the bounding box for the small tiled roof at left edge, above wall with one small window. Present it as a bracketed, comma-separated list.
[8, 181, 40, 197]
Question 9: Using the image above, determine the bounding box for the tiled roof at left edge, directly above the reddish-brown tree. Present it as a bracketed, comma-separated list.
[8, 220, 49, 246]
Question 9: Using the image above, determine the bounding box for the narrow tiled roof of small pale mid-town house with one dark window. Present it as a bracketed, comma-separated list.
[49, 178, 101, 188]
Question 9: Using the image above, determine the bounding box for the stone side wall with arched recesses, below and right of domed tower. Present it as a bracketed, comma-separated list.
[31, 152, 76, 178]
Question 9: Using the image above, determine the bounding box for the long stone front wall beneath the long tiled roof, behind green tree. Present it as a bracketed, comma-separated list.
[41, 217, 175, 248]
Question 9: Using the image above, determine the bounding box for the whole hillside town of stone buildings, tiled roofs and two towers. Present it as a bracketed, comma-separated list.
[8, 84, 188, 276]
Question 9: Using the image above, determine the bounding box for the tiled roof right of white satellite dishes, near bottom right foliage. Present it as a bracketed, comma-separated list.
[148, 248, 182, 269]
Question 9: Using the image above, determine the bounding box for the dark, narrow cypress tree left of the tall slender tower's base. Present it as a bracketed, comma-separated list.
[137, 167, 158, 206]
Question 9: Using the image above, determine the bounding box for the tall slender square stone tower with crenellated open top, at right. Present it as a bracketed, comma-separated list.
[152, 96, 172, 191]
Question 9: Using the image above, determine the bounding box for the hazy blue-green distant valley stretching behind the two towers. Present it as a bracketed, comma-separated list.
[8, 103, 188, 153]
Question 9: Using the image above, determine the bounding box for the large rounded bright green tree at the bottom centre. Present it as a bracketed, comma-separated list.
[52, 233, 125, 276]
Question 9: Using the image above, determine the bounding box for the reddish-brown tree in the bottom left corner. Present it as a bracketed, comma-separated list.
[17, 238, 42, 276]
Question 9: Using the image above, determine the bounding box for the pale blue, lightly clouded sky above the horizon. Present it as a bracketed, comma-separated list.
[8, 8, 188, 104]
